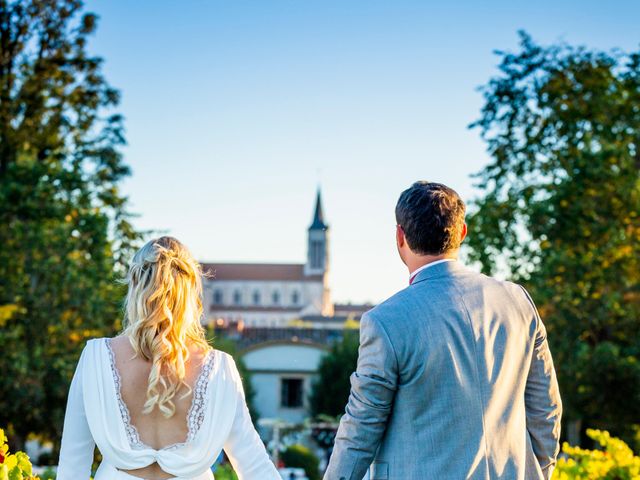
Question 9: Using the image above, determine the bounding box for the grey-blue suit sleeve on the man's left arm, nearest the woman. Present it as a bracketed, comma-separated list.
[324, 314, 398, 480]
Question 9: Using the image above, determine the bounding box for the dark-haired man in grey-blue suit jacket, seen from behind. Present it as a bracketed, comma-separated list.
[324, 182, 562, 480]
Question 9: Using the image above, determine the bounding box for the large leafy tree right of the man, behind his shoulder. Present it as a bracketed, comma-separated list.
[468, 33, 640, 444]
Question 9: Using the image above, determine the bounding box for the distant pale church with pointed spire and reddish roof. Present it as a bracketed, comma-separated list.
[202, 189, 334, 328]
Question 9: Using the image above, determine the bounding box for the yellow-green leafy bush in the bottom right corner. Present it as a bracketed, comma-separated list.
[553, 429, 640, 480]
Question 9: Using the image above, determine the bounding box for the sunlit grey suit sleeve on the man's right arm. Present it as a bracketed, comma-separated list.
[523, 288, 562, 479]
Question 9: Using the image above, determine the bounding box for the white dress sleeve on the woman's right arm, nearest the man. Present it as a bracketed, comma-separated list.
[224, 357, 281, 480]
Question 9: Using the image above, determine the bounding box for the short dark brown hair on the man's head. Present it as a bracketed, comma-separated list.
[396, 181, 465, 255]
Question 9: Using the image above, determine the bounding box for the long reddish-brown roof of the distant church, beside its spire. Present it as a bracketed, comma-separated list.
[202, 263, 322, 282]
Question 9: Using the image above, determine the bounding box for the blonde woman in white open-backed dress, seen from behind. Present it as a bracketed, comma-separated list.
[57, 237, 280, 480]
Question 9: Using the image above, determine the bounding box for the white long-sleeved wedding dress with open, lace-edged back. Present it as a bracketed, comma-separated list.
[57, 338, 280, 480]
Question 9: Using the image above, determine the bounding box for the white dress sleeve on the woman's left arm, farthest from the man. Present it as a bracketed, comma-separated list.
[57, 347, 95, 480]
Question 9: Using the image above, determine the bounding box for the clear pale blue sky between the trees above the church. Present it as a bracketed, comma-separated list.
[87, 0, 640, 302]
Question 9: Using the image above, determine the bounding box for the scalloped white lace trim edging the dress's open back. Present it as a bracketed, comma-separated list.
[104, 338, 214, 450]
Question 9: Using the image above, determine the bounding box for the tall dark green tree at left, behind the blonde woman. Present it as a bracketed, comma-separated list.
[0, 0, 138, 447]
